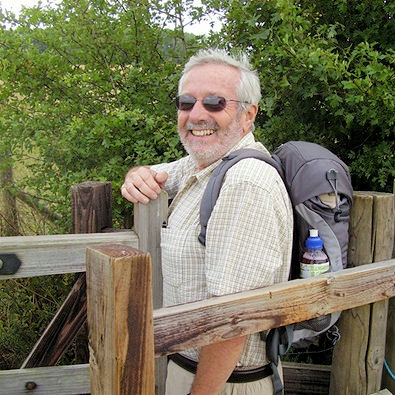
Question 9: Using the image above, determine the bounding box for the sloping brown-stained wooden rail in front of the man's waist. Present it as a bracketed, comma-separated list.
[154, 260, 395, 355]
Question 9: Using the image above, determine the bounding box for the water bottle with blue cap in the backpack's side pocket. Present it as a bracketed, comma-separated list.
[300, 229, 329, 278]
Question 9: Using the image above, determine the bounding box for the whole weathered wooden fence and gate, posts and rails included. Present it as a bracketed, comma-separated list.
[0, 184, 395, 395]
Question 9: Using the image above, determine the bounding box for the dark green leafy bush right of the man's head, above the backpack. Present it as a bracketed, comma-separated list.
[215, 0, 395, 191]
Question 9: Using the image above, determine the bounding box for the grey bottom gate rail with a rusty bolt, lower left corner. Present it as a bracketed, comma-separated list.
[0, 364, 90, 395]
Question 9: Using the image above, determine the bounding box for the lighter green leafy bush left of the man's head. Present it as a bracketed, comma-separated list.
[0, 1, 198, 231]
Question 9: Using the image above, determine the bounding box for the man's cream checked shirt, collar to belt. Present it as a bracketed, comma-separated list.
[151, 133, 293, 369]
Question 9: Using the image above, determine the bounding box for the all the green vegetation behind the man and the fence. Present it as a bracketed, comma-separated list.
[0, 0, 395, 368]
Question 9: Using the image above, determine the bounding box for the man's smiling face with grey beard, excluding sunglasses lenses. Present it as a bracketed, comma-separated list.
[178, 64, 257, 169]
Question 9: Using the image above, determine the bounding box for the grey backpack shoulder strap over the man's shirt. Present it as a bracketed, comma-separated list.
[199, 148, 281, 246]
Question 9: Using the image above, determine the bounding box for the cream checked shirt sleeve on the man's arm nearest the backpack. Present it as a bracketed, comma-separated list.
[205, 159, 292, 296]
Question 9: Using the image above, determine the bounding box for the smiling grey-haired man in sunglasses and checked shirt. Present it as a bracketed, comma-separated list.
[121, 49, 292, 395]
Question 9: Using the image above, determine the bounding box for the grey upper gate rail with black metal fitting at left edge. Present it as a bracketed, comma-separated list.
[0, 231, 138, 280]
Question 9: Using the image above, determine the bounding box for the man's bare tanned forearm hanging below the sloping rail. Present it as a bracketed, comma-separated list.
[191, 336, 246, 395]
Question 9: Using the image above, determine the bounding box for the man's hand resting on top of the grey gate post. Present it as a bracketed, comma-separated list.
[121, 166, 169, 204]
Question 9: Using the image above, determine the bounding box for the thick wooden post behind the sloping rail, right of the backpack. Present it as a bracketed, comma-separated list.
[329, 192, 394, 395]
